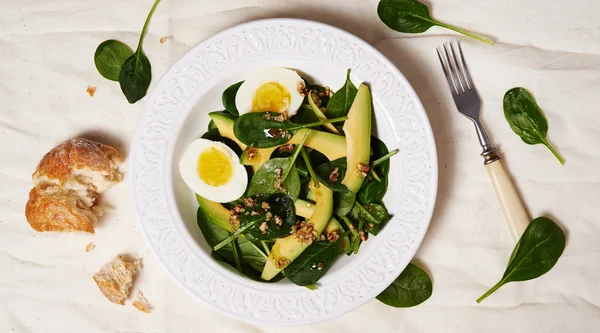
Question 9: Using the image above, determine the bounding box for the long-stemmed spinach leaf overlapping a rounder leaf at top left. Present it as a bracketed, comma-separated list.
[119, 0, 160, 104]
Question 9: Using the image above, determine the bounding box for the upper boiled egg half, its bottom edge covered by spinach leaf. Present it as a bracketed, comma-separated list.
[235, 68, 306, 118]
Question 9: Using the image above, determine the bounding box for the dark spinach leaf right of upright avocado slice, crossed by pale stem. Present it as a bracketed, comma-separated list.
[356, 136, 390, 205]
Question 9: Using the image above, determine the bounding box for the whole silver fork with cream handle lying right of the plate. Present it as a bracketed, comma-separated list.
[436, 42, 530, 240]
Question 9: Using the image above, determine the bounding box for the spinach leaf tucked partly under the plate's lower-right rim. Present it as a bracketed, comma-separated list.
[377, 264, 433, 308]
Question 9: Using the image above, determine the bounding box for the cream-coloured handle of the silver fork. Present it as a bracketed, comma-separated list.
[485, 159, 530, 241]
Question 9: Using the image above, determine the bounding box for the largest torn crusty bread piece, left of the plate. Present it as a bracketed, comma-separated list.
[25, 138, 123, 234]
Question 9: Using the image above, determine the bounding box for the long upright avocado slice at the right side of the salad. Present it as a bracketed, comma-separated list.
[342, 83, 372, 193]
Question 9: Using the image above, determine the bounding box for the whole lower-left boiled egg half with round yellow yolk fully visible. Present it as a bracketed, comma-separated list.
[179, 139, 248, 202]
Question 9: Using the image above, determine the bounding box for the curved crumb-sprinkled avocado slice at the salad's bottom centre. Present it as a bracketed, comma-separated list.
[261, 182, 333, 280]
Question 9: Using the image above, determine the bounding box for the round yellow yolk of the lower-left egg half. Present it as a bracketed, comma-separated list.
[198, 147, 233, 186]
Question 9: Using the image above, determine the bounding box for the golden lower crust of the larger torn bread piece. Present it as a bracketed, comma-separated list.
[25, 187, 95, 234]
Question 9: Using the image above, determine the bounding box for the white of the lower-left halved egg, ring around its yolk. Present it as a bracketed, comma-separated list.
[179, 139, 248, 202]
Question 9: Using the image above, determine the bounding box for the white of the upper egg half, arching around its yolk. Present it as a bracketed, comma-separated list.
[235, 68, 304, 118]
